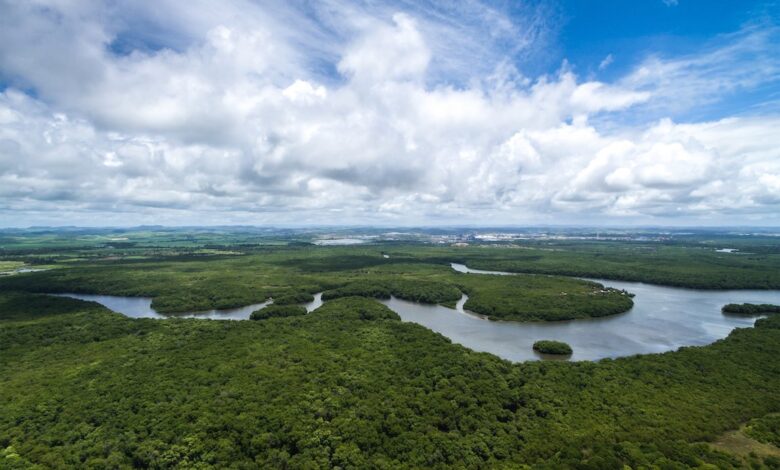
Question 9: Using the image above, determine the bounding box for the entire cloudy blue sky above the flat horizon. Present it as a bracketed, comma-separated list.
[0, 0, 780, 227]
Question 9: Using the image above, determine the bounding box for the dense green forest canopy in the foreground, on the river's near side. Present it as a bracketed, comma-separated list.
[0, 292, 780, 469]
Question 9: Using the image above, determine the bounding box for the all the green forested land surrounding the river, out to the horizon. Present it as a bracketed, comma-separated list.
[0, 231, 780, 469]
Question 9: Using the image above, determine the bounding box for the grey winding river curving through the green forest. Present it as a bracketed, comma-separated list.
[54, 263, 780, 361]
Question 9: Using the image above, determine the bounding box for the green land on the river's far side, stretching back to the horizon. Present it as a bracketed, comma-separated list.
[0, 229, 780, 321]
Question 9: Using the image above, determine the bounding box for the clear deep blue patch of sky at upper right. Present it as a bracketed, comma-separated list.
[548, 0, 780, 120]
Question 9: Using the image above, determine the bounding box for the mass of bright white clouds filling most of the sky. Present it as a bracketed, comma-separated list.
[0, 2, 780, 225]
